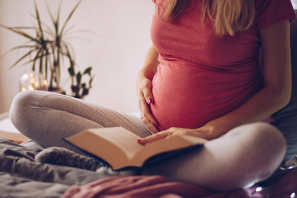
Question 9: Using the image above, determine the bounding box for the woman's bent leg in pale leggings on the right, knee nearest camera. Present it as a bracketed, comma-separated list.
[143, 123, 286, 191]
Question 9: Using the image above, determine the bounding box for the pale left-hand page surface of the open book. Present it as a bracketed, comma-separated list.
[89, 127, 144, 159]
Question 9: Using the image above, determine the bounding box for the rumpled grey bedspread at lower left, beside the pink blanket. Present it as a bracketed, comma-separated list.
[0, 137, 109, 198]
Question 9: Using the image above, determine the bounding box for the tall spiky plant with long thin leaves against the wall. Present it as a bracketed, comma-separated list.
[0, 0, 82, 91]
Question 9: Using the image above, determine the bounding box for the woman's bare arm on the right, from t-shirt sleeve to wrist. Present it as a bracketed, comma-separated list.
[202, 21, 292, 137]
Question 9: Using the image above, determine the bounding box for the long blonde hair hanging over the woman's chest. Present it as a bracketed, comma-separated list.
[161, 0, 255, 36]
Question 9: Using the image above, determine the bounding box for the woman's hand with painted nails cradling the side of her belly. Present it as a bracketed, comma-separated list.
[136, 71, 160, 133]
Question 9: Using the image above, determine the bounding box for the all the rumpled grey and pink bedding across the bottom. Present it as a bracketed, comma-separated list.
[0, 137, 297, 198]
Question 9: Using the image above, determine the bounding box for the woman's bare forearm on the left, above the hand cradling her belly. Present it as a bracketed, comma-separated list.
[139, 46, 159, 79]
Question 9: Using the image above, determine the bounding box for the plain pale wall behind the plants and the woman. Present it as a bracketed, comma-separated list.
[0, 0, 154, 113]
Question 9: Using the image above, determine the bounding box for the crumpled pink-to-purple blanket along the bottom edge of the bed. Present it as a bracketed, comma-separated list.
[62, 169, 297, 198]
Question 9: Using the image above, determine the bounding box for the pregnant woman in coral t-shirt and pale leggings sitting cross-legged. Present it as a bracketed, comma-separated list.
[10, 0, 297, 191]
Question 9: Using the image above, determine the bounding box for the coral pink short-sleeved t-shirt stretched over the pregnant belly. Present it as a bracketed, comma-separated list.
[151, 0, 295, 130]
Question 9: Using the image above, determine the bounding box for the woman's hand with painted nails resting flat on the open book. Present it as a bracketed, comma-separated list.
[138, 125, 217, 144]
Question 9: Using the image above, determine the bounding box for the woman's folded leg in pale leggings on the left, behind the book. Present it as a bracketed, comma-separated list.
[9, 91, 152, 154]
